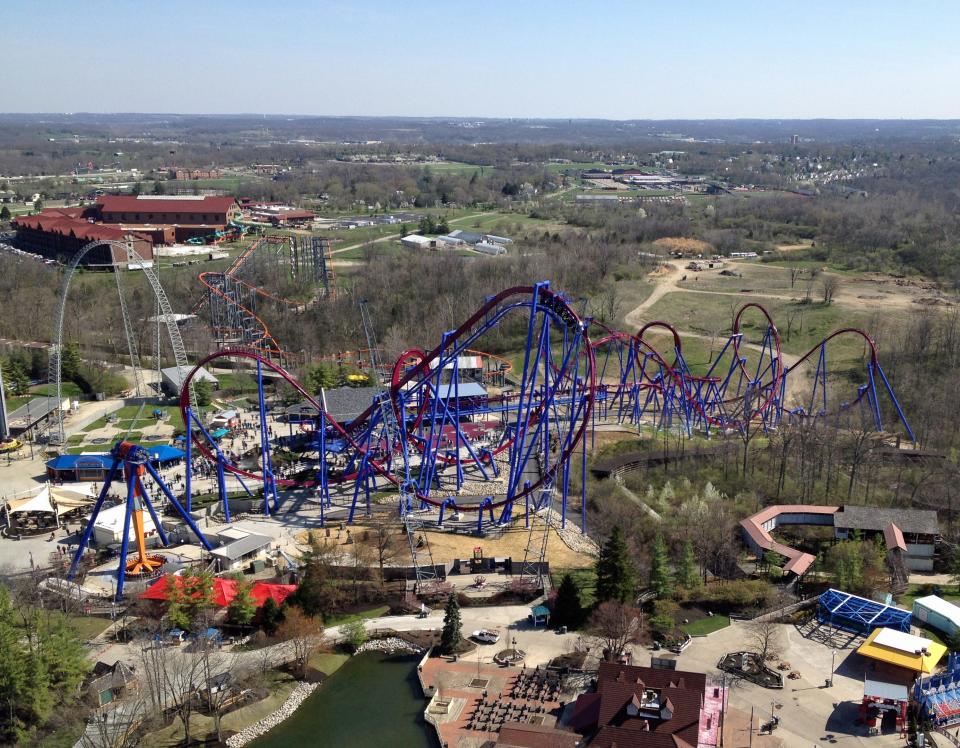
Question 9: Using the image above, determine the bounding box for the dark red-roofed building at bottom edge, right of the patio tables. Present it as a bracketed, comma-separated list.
[569, 662, 724, 748]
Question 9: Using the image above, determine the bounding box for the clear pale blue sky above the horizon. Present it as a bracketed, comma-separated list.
[7, 0, 960, 119]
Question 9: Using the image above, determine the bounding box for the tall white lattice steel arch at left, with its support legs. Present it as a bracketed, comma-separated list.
[47, 239, 197, 444]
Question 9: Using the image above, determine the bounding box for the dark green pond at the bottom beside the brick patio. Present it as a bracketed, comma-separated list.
[250, 652, 438, 748]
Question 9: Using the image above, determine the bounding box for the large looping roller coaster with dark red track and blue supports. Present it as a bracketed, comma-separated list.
[60, 272, 915, 600]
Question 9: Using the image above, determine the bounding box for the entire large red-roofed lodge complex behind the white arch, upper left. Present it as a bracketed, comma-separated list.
[13, 195, 240, 266]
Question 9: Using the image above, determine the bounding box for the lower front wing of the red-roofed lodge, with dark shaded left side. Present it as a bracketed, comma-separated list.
[13, 208, 153, 266]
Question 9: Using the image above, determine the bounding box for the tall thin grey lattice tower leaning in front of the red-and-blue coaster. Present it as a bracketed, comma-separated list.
[360, 300, 437, 592]
